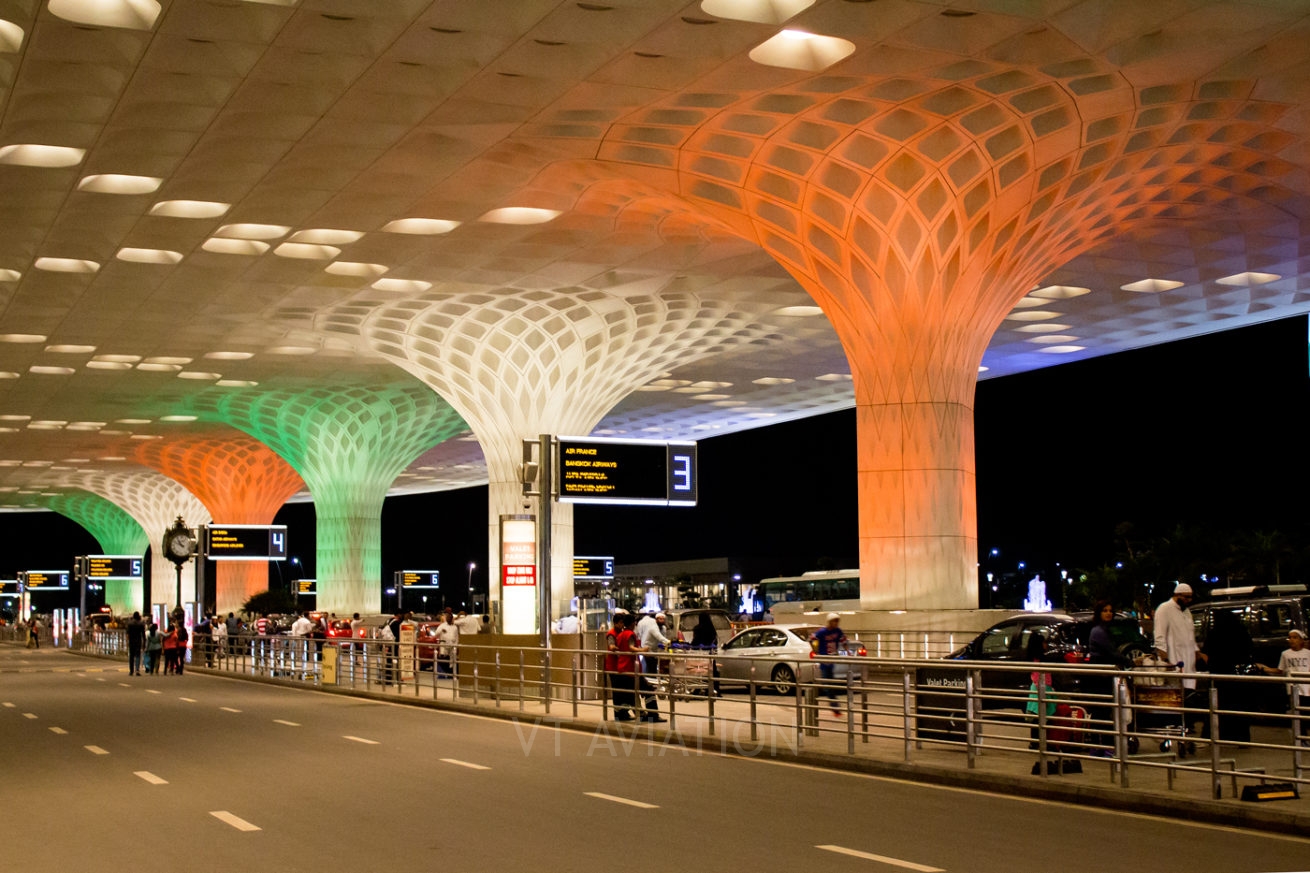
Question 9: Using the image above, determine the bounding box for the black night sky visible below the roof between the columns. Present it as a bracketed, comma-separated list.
[0, 310, 1310, 605]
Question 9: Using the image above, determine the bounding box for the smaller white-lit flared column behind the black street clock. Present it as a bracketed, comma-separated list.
[69, 467, 212, 608]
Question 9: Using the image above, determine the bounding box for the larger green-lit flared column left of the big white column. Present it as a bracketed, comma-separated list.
[195, 380, 468, 613]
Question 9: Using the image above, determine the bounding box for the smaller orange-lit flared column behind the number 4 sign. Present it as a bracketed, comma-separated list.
[136, 434, 304, 613]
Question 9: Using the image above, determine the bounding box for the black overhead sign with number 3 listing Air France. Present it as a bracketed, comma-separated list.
[555, 437, 697, 506]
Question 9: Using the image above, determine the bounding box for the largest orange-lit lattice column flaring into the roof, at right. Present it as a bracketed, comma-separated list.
[586, 68, 1296, 607]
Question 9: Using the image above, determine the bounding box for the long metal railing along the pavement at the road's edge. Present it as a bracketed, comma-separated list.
[56, 631, 1310, 798]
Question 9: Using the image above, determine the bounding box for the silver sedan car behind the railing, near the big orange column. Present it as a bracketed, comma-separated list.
[718, 624, 869, 695]
